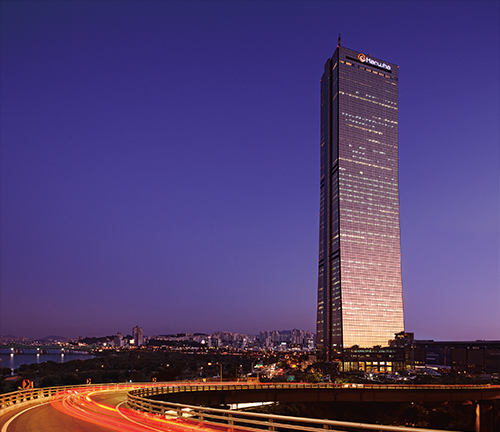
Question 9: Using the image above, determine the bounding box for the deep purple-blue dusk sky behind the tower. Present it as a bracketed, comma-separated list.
[0, 0, 500, 340]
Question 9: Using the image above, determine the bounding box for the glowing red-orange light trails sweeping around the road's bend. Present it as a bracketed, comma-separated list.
[50, 385, 242, 432]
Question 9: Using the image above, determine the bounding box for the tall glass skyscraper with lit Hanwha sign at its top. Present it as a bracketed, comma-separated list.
[316, 44, 404, 361]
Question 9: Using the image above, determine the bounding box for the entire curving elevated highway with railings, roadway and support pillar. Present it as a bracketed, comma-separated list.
[0, 382, 500, 432]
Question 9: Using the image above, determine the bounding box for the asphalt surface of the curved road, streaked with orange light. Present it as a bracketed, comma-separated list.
[0, 384, 236, 432]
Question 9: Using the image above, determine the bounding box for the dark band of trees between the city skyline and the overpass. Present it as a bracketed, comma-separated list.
[0, 349, 498, 393]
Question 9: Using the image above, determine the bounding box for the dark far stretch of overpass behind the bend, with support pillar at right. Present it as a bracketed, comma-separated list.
[128, 384, 500, 432]
